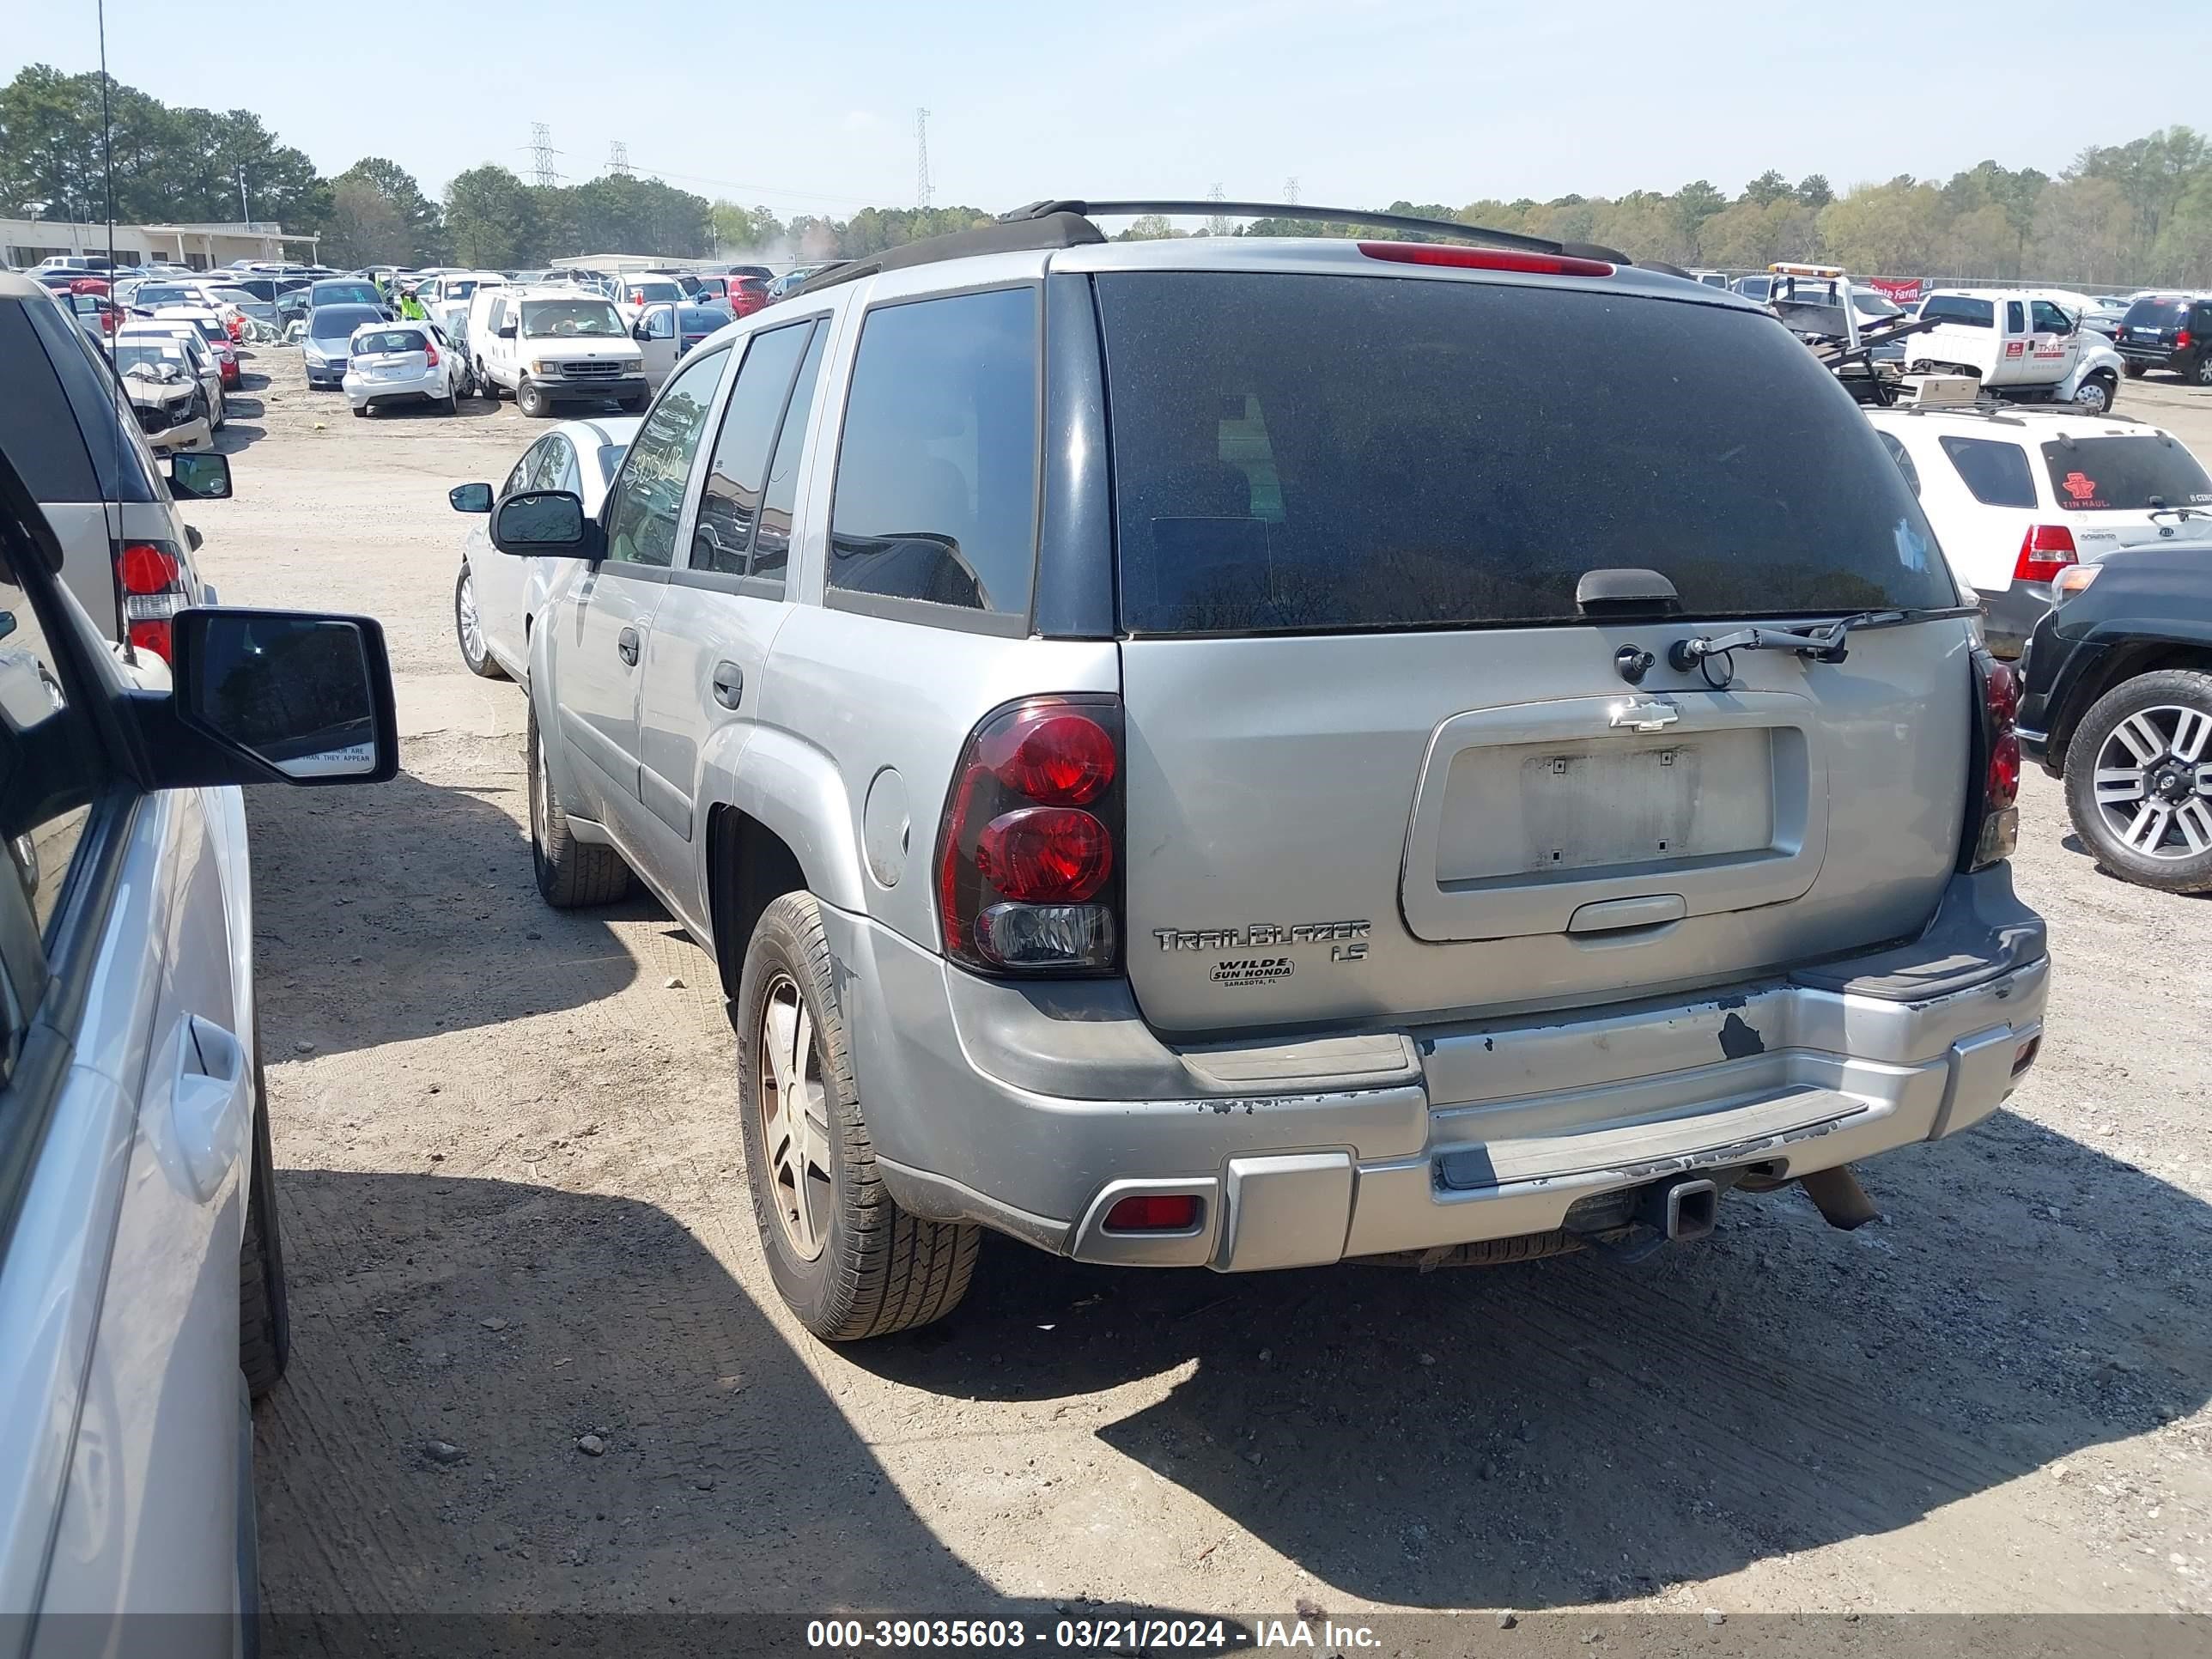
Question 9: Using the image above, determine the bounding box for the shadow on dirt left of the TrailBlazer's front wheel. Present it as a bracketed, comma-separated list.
[246, 772, 664, 1060]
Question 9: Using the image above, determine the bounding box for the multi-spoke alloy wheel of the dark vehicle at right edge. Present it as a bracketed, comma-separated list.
[2066, 668, 2212, 894]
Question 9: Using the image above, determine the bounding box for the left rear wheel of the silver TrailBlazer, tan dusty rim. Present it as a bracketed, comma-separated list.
[737, 894, 982, 1343]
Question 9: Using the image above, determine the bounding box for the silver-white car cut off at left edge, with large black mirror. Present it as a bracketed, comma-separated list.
[0, 442, 398, 1655]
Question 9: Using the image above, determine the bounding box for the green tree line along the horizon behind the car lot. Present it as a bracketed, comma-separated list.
[13, 64, 2212, 288]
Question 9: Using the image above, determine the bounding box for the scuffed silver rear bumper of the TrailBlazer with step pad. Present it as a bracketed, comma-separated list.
[830, 865, 2051, 1272]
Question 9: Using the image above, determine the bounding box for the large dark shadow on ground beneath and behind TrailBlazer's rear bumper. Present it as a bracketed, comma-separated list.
[838, 1113, 2212, 1608]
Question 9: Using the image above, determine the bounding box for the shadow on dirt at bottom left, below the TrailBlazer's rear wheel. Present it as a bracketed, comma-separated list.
[254, 1168, 1212, 1656]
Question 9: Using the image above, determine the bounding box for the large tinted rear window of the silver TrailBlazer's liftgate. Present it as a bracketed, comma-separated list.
[1097, 272, 1955, 633]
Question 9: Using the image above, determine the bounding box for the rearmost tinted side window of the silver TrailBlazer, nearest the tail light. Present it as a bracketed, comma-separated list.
[830, 288, 1037, 615]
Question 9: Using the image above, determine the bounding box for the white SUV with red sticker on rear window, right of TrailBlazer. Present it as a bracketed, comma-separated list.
[1867, 407, 2212, 657]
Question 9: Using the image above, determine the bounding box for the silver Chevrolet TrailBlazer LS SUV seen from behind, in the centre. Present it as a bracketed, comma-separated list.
[493, 204, 2048, 1338]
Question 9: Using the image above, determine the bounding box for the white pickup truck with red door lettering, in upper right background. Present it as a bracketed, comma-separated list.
[1905, 288, 2121, 414]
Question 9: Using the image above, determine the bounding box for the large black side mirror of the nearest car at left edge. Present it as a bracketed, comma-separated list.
[158, 606, 400, 787]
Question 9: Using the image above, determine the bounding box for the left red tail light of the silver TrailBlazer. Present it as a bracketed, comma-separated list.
[936, 696, 1121, 973]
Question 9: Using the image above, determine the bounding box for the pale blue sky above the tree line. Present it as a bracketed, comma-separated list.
[0, 0, 2208, 216]
